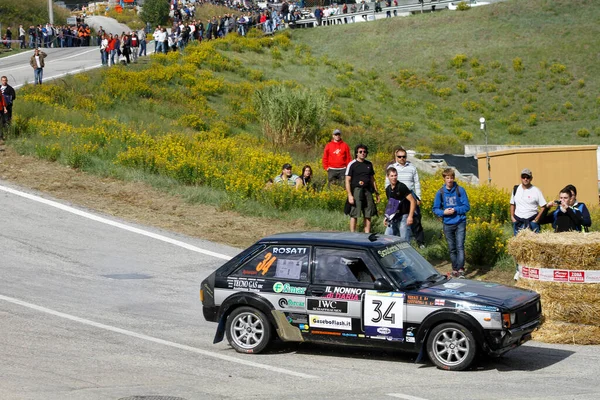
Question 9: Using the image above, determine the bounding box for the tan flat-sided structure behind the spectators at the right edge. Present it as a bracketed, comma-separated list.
[476, 145, 598, 205]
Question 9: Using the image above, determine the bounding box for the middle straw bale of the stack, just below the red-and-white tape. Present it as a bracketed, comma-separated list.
[516, 279, 600, 327]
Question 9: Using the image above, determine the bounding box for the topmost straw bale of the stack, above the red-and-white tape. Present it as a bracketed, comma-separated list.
[508, 230, 600, 270]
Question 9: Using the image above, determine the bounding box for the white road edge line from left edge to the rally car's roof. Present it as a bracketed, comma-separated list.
[0, 186, 231, 260]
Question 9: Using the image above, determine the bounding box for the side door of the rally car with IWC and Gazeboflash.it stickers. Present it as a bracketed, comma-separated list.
[306, 247, 381, 339]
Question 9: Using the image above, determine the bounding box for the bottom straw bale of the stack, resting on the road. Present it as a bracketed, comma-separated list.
[533, 321, 600, 345]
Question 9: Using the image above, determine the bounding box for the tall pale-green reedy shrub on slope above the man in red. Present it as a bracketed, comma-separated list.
[254, 85, 329, 146]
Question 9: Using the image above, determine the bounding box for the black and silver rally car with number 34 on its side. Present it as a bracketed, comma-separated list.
[200, 232, 541, 370]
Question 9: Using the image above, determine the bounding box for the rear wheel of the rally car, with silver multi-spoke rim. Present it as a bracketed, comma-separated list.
[225, 307, 272, 353]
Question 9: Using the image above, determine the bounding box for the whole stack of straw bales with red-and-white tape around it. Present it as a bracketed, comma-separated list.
[508, 230, 600, 344]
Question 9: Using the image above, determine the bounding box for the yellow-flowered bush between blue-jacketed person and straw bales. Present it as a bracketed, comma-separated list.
[465, 218, 506, 266]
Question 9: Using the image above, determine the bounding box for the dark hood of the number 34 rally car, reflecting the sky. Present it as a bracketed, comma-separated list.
[417, 279, 539, 309]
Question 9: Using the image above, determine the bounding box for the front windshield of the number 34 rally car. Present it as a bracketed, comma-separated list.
[377, 242, 442, 287]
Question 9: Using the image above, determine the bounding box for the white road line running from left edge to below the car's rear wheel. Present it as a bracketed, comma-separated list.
[0, 295, 316, 379]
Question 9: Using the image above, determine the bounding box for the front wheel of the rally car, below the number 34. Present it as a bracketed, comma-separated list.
[427, 322, 477, 371]
